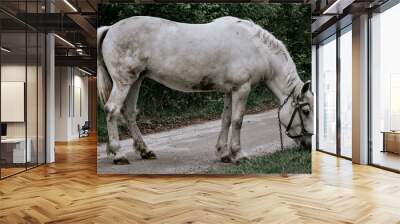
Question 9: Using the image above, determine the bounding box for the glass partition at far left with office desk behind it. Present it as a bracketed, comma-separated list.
[0, 1, 46, 179]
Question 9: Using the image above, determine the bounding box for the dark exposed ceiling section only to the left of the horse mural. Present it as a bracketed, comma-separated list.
[0, 0, 104, 73]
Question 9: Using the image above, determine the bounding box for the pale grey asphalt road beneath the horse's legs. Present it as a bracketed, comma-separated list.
[97, 110, 294, 174]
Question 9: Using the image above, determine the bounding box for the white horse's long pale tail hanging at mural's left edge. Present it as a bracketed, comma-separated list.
[97, 26, 113, 105]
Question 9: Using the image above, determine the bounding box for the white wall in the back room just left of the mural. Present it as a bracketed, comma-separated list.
[55, 67, 88, 141]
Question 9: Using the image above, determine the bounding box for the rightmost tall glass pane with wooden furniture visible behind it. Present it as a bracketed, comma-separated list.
[370, 4, 400, 170]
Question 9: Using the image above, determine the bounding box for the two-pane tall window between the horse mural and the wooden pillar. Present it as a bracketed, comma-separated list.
[317, 24, 353, 158]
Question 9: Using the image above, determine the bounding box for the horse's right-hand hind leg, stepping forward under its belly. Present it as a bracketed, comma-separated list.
[122, 75, 156, 159]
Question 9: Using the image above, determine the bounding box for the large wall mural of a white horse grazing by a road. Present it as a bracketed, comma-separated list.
[97, 3, 314, 175]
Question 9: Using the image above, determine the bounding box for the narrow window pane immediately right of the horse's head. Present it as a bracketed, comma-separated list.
[317, 35, 336, 154]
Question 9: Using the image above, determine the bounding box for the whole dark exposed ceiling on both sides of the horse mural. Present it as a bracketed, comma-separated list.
[0, 0, 384, 71]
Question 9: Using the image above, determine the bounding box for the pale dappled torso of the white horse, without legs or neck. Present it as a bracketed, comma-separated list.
[105, 17, 265, 91]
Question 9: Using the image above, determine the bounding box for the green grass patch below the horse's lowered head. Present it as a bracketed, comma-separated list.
[208, 147, 311, 174]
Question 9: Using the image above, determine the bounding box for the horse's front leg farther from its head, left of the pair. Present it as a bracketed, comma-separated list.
[215, 92, 232, 162]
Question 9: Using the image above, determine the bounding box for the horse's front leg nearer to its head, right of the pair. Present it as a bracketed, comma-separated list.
[230, 83, 251, 162]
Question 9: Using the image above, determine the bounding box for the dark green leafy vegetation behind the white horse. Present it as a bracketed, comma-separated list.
[98, 3, 311, 141]
